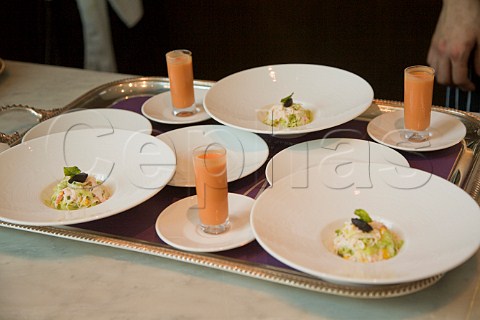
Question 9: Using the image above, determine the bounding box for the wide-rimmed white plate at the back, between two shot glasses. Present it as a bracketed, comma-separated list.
[203, 64, 373, 135]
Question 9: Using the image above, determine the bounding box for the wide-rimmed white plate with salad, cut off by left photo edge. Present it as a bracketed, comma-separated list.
[0, 129, 175, 226]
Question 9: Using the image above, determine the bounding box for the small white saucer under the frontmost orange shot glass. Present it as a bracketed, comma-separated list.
[155, 193, 255, 252]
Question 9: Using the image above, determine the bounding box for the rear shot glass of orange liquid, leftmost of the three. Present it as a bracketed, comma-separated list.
[165, 50, 196, 117]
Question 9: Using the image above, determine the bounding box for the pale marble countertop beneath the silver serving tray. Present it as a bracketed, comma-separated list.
[0, 61, 480, 320]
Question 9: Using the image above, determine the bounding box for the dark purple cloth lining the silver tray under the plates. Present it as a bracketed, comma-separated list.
[75, 96, 460, 269]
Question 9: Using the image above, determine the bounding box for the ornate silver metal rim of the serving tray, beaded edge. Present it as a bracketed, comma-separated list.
[0, 77, 480, 299]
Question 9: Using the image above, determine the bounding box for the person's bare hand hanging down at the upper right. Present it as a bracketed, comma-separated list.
[427, 0, 480, 91]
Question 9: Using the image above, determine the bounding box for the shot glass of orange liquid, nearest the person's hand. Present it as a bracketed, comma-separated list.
[404, 66, 435, 142]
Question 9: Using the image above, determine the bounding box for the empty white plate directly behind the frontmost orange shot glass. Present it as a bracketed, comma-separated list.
[157, 125, 268, 187]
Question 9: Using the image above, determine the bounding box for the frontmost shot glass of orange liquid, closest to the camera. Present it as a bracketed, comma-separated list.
[193, 143, 230, 234]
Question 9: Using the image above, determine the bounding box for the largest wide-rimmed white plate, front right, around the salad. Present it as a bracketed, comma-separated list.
[251, 164, 480, 285]
